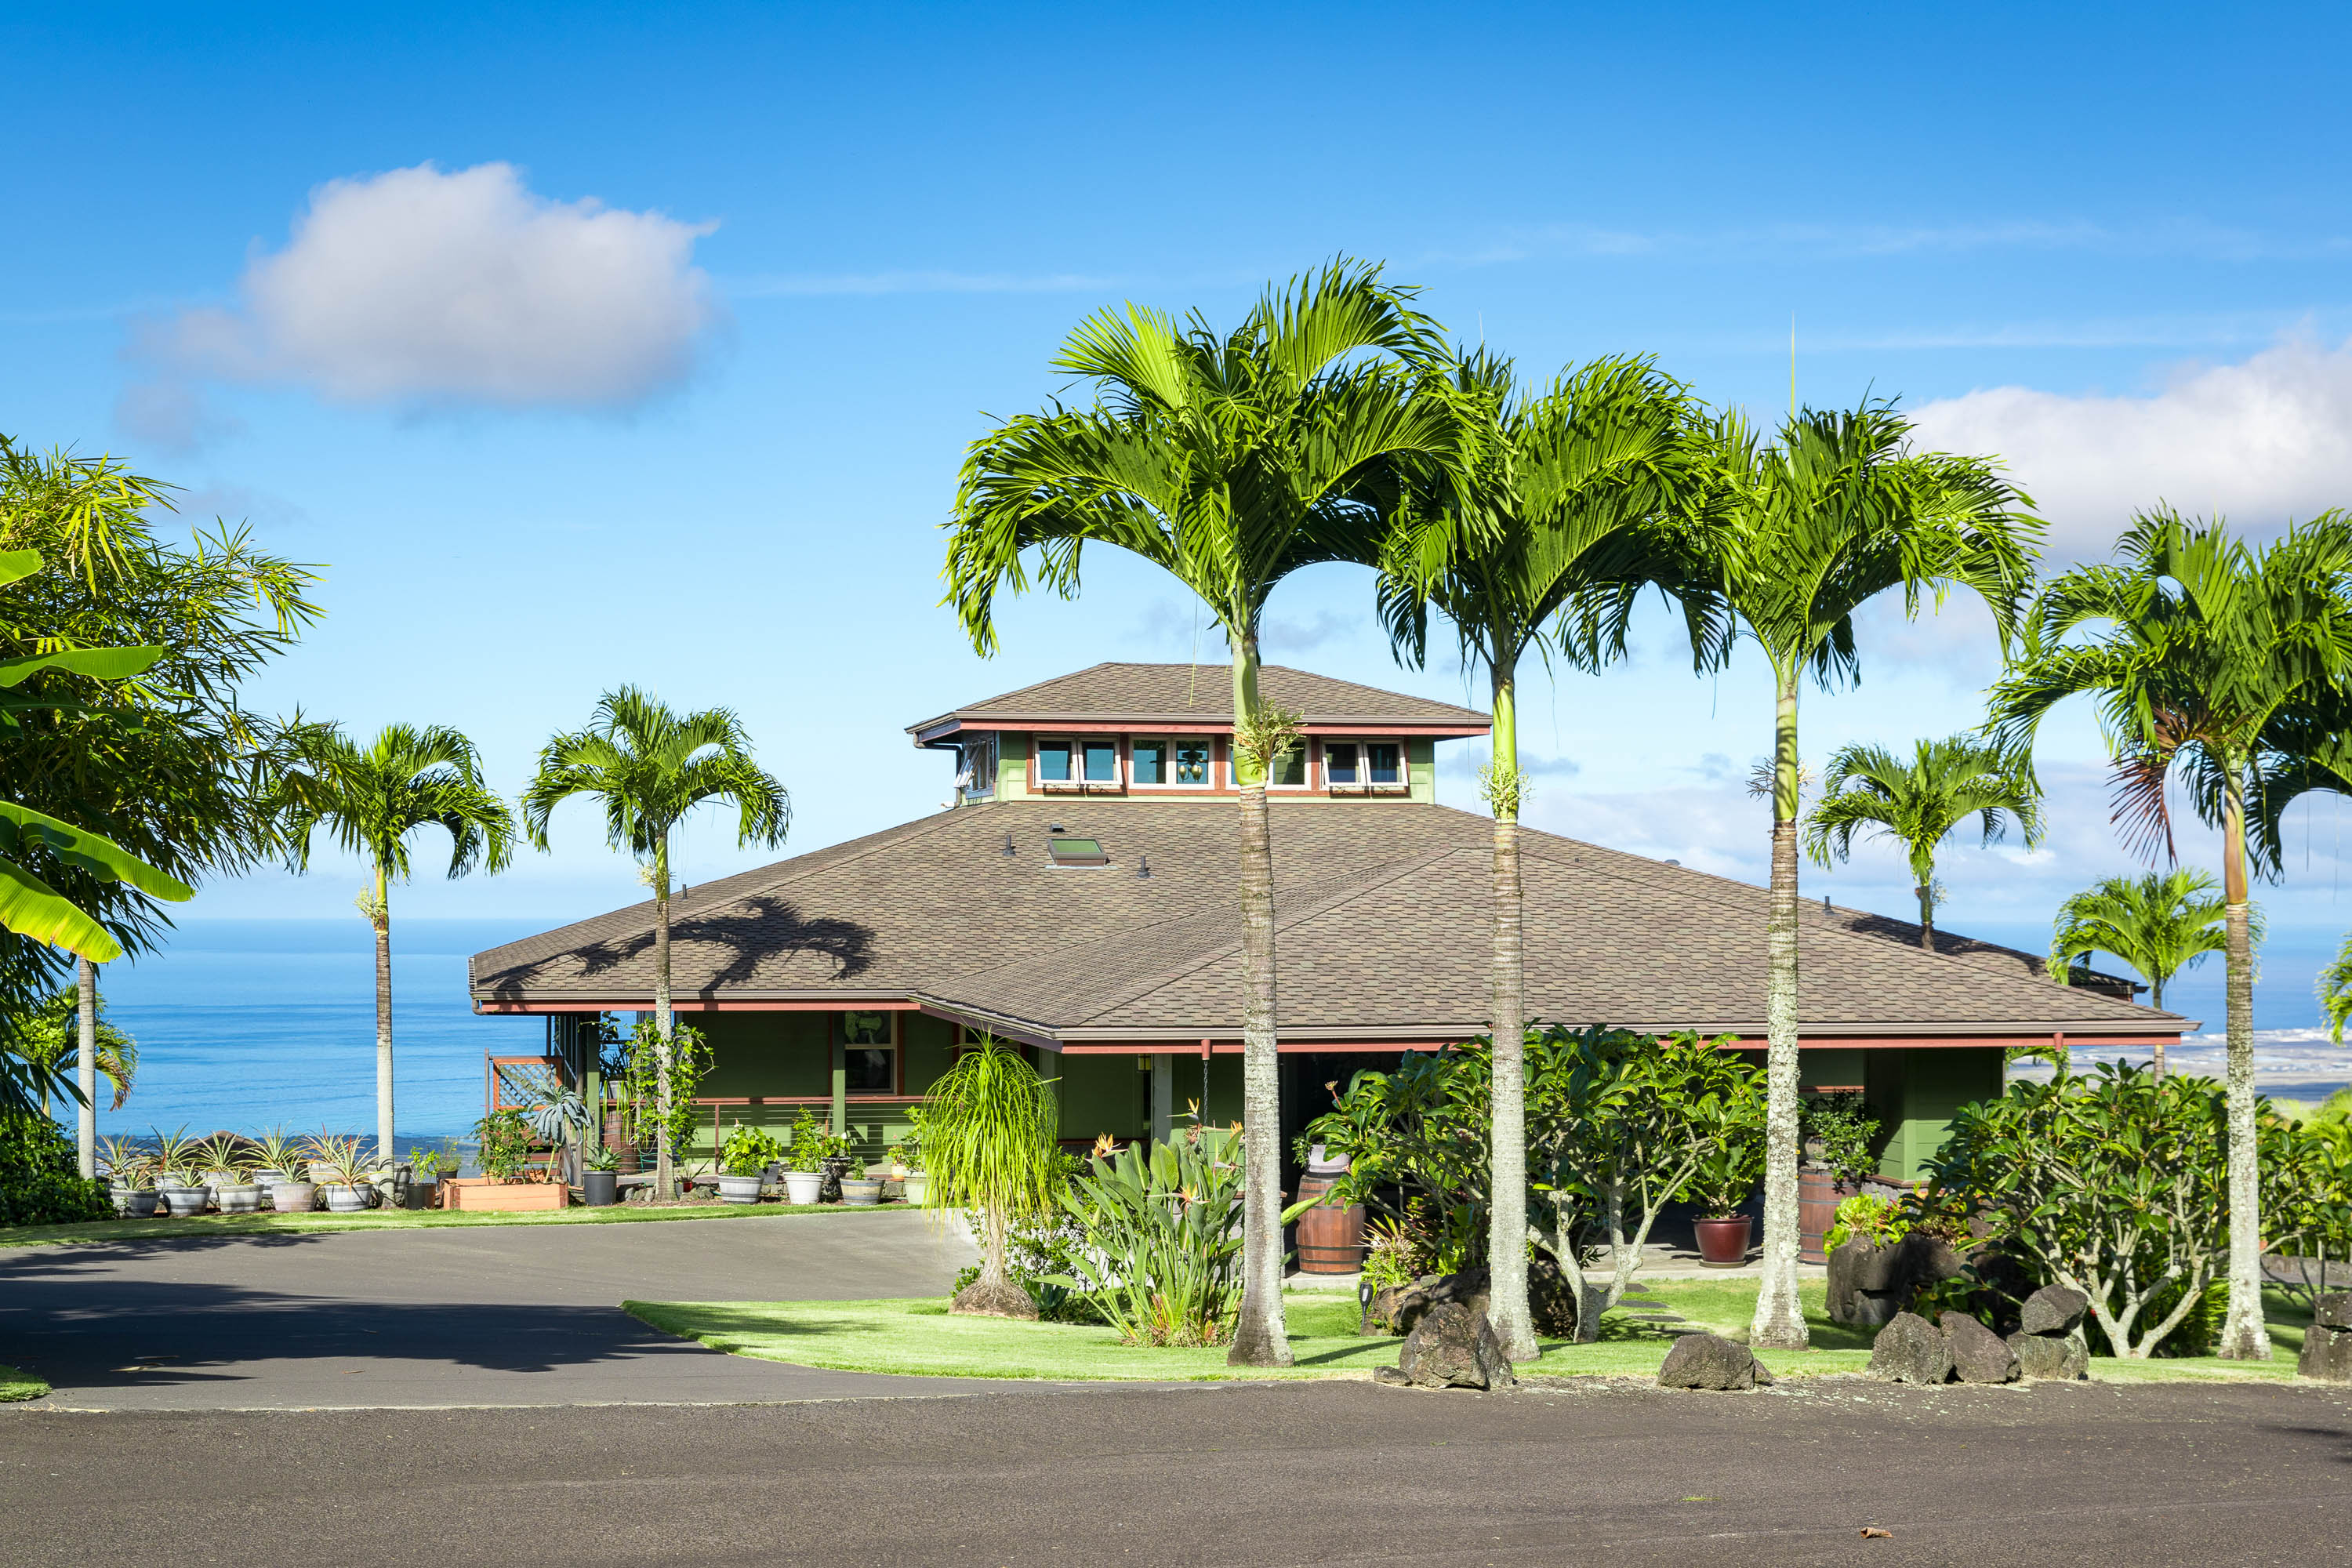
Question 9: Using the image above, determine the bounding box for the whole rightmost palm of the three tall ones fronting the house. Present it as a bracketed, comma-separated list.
[1710, 405, 2042, 1347]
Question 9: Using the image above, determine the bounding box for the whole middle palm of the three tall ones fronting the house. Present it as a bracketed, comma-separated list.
[1381, 350, 1705, 1361]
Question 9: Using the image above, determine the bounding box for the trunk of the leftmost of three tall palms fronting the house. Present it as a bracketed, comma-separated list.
[1225, 630, 1291, 1366]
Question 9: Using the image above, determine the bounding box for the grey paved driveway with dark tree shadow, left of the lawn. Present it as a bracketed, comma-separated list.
[0, 1213, 971, 1410]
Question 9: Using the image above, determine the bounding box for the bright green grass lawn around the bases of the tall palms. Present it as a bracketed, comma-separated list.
[621, 1279, 2307, 1382]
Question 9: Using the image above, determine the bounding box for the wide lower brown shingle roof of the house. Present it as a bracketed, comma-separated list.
[473, 801, 2185, 1044]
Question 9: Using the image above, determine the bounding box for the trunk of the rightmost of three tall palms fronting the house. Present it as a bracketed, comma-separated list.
[1748, 659, 1809, 1349]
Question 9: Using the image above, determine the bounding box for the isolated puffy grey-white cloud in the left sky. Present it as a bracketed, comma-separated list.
[125, 162, 717, 428]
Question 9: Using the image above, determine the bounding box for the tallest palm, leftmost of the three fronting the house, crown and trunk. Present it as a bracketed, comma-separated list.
[943, 261, 1463, 1366]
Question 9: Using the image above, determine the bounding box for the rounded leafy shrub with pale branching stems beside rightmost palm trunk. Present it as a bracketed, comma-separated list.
[1929, 1062, 2293, 1359]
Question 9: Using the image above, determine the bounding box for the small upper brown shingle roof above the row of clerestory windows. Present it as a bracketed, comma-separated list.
[908, 663, 1486, 736]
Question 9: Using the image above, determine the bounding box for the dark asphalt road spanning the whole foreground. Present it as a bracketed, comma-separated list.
[0, 1380, 2352, 1568]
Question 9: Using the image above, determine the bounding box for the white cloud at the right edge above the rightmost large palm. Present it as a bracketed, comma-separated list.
[1912, 339, 2352, 560]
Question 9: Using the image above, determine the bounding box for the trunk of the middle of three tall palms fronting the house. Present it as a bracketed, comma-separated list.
[1486, 659, 1543, 1361]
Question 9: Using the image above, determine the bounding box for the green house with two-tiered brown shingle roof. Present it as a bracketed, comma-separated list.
[470, 663, 2190, 1178]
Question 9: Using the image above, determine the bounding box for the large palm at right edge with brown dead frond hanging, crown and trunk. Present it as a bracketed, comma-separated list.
[1990, 506, 2352, 1361]
